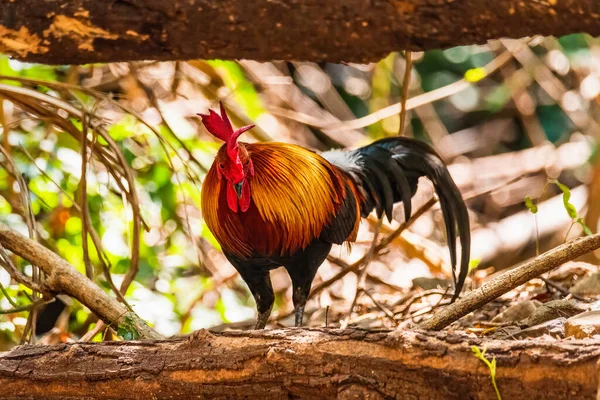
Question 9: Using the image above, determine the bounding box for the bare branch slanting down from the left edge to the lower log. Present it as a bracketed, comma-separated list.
[0, 223, 161, 339]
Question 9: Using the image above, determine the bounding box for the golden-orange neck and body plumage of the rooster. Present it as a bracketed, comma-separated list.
[202, 143, 360, 258]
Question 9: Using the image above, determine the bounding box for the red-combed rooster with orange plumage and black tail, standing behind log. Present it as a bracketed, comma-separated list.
[198, 105, 471, 329]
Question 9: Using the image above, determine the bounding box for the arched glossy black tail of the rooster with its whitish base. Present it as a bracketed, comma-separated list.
[323, 137, 471, 301]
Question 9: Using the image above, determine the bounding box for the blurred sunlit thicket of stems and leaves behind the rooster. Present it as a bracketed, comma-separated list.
[0, 35, 600, 350]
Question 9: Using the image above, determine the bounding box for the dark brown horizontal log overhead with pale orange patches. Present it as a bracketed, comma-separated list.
[0, 0, 600, 64]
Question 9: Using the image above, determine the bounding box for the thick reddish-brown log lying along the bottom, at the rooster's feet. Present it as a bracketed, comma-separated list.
[0, 329, 600, 400]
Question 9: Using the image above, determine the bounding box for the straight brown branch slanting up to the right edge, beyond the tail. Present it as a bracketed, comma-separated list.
[419, 234, 600, 331]
